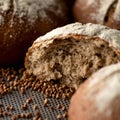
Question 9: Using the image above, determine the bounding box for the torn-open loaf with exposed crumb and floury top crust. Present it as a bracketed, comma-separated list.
[25, 23, 120, 88]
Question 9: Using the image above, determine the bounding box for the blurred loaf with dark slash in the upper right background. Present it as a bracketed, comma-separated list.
[73, 0, 120, 30]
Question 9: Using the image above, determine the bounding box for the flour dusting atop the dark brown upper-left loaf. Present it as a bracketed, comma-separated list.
[0, 0, 64, 25]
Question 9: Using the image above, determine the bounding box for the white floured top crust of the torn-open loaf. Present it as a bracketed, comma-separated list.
[34, 23, 120, 49]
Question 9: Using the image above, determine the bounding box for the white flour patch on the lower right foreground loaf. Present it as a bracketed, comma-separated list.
[88, 63, 120, 115]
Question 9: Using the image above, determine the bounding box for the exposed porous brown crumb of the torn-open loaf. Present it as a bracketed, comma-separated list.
[29, 36, 120, 88]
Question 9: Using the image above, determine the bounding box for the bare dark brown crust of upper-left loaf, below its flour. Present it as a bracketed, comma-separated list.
[0, 0, 68, 65]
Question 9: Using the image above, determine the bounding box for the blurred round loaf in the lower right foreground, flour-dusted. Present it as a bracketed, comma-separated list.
[68, 63, 120, 120]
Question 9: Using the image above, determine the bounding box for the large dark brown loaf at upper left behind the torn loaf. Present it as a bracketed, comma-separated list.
[0, 0, 69, 65]
